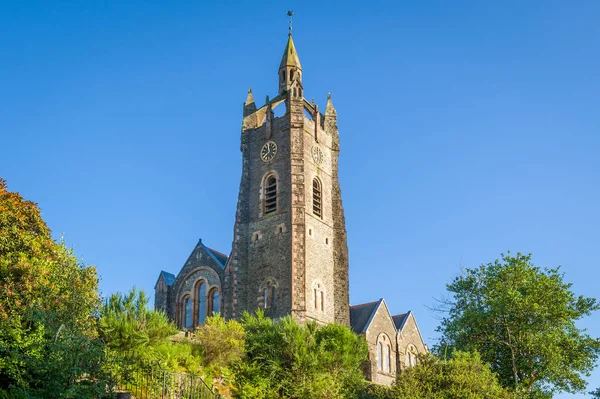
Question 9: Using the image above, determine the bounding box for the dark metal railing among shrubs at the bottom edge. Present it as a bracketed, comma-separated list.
[116, 360, 220, 399]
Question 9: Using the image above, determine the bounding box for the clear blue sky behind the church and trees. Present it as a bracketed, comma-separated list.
[0, 0, 600, 398]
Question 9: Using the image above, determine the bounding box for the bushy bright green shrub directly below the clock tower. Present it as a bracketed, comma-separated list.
[235, 312, 367, 398]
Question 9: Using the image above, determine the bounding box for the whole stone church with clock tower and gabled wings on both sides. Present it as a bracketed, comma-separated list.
[155, 29, 428, 384]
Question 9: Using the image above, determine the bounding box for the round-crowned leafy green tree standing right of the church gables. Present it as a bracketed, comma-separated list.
[437, 253, 600, 397]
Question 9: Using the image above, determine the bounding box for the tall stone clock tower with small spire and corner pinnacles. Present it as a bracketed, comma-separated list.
[223, 30, 350, 324]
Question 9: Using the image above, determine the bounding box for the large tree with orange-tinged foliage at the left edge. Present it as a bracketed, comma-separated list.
[0, 179, 107, 398]
